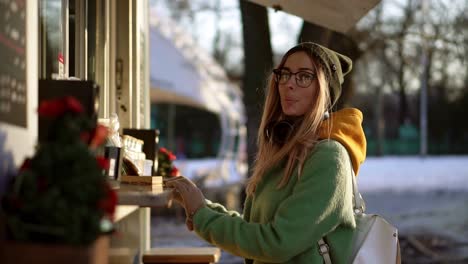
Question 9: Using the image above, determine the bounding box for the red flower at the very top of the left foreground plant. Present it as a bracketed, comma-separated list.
[38, 96, 84, 117]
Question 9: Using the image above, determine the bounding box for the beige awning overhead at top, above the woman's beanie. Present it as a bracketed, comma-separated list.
[250, 0, 380, 33]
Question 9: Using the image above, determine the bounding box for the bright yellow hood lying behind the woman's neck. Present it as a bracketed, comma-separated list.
[319, 108, 367, 175]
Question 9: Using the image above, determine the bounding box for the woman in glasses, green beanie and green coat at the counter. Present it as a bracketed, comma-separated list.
[167, 42, 366, 264]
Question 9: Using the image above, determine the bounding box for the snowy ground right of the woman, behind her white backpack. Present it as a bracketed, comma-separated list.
[358, 156, 468, 240]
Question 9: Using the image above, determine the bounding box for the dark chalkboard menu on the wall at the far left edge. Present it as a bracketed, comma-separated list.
[0, 0, 27, 127]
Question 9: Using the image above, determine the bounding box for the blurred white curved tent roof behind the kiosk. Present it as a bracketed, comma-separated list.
[150, 14, 245, 122]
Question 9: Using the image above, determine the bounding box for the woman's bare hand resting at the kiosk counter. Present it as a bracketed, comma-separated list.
[166, 176, 206, 231]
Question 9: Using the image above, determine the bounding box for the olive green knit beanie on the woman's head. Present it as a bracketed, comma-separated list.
[284, 42, 353, 107]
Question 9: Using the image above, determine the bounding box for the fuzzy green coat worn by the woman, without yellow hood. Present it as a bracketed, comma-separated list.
[194, 140, 355, 264]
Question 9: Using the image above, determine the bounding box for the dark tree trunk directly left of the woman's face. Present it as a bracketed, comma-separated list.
[240, 0, 273, 177]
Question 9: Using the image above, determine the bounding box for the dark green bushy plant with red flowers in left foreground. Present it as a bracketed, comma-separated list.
[5, 96, 117, 243]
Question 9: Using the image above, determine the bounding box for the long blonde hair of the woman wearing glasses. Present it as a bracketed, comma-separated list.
[246, 49, 331, 196]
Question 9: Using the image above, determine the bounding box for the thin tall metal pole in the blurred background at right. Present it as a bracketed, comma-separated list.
[419, 0, 429, 157]
